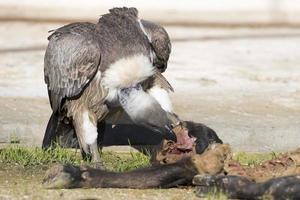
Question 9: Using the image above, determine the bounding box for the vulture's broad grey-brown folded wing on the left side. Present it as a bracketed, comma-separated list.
[44, 23, 101, 112]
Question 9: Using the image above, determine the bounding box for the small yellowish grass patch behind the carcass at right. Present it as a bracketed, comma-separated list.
[233, 152, 277, 166]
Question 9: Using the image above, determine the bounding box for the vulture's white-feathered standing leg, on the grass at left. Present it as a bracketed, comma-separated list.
[73, 109, 104, 168]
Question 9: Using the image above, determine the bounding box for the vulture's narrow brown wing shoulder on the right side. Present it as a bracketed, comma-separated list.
[141, 20, 171, 72]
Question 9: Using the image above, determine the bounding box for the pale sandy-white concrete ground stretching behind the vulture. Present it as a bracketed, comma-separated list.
[0, 21, 300, 151]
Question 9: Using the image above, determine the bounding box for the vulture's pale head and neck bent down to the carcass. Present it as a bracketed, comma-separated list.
[118, 85, 176, 140]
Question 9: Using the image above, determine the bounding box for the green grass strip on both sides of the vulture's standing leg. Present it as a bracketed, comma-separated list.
[0, 145, 150, 172]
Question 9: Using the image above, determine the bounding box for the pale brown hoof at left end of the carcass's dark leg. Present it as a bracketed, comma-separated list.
[43, 165, 80, 189]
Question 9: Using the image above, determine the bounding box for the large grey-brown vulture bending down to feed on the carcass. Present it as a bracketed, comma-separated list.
[42, 7, 179, 168]
